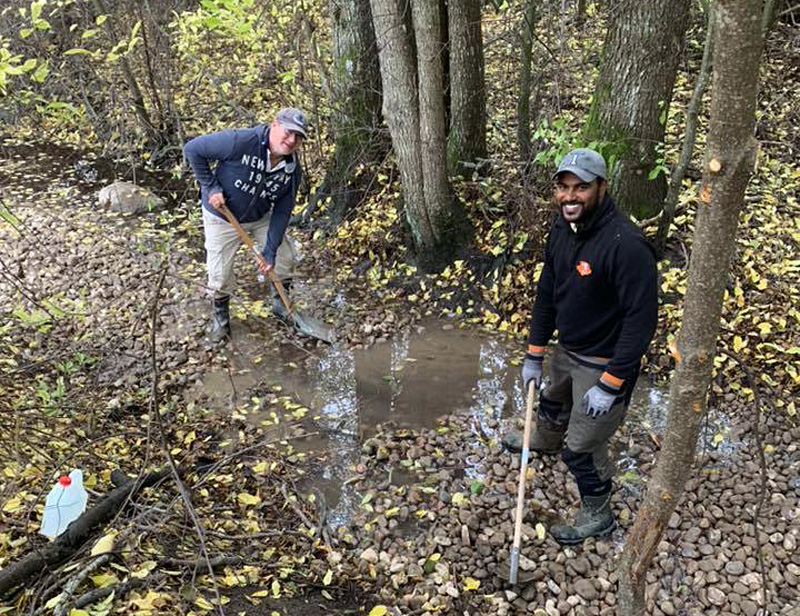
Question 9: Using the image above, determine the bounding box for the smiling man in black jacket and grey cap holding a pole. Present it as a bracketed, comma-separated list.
[503, 148, 658, 545]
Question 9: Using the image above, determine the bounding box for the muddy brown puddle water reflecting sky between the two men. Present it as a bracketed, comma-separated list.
[194, 321, 729, 525]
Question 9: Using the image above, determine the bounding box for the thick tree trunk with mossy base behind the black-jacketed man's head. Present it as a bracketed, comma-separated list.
[584, 0, 690, 219]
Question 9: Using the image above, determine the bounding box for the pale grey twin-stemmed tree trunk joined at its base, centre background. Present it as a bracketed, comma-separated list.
[371, 0, 466, 271]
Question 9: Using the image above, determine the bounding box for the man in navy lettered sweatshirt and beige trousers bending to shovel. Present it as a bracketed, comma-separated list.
[183, 108, 307, 343]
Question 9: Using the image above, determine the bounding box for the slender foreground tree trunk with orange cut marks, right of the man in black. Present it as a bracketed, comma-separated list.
[618, 0, 762, 616]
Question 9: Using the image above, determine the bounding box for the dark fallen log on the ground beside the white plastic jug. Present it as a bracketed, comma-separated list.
[0, 468, 171, 597]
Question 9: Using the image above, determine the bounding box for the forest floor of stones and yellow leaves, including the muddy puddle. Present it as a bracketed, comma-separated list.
[0, 13, 800, 616]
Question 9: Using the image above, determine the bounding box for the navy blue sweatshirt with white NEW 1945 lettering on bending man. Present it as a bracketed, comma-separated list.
[183, 125, 302, 265]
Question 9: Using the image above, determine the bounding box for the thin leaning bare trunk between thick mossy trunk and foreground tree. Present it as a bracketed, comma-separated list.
[655, 1, 714, 258]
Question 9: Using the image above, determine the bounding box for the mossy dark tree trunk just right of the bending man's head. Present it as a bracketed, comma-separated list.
[303, 0, 388, 222]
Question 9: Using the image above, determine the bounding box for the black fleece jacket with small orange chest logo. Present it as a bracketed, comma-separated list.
[528, 195, 658, 381]
